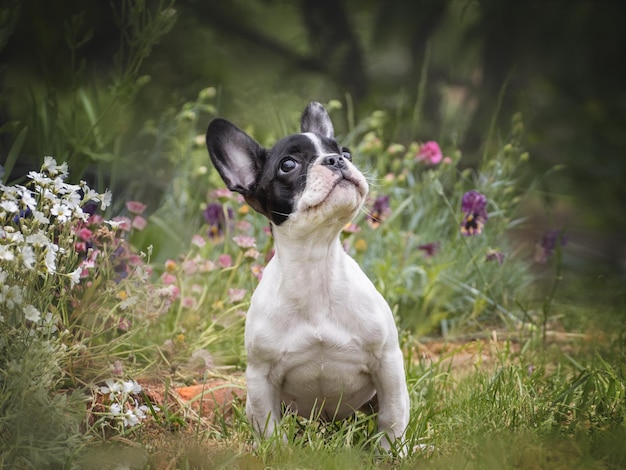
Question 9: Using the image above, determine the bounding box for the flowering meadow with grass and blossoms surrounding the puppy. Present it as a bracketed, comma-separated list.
[0, 2, 626, 469]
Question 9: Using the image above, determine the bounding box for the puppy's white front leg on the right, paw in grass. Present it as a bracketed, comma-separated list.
[373, 348, 410, 455]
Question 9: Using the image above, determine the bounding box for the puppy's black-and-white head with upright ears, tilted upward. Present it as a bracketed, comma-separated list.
[206, 102, 368, 234]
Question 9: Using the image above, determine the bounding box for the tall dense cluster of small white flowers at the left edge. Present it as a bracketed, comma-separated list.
[0, 157, 111, 324]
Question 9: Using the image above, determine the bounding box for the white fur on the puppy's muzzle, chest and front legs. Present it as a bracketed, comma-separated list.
[245, 150, 409, 449]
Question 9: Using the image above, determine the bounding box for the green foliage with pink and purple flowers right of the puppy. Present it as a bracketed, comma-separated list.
[332, 106, 532, 334]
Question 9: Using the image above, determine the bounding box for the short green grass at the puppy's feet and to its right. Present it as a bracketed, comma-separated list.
[69, 328, 626, 469]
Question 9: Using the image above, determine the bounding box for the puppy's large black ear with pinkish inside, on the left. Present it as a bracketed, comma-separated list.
[206, 118, 266, 196]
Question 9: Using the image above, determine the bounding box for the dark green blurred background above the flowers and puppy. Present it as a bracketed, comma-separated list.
[0, 0, 626, 282]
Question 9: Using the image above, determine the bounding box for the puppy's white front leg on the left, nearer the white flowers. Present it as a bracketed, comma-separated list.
[246, 363, 284, 440]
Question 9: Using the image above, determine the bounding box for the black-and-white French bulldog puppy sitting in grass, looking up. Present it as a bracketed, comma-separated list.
[206, 103, 409, 449]
